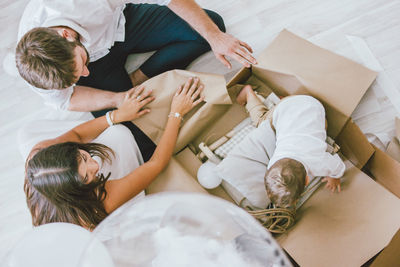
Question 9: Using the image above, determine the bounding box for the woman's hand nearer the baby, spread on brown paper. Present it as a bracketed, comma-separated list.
[171, 77, 204, 116]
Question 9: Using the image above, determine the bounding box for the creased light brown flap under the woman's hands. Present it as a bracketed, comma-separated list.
[134, 70, 232, 152]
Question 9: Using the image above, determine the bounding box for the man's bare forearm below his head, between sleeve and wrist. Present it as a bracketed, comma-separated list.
[68, 85, 126, 111]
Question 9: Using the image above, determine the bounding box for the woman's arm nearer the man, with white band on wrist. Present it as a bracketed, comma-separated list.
[28, 86, 154, 158]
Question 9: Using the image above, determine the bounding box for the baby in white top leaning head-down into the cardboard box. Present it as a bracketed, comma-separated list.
[236, 85, 345, 208]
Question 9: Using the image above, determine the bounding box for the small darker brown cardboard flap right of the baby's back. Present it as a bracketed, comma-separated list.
[336, 120, 375, 169]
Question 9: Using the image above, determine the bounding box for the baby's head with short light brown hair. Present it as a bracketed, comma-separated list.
[264, 158, 307, 208]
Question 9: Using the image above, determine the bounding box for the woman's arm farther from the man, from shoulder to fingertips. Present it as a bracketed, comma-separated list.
[104, 78, 204, 212]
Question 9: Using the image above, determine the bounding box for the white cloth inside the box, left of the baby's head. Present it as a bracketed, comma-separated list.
[199, 93, 280, 209]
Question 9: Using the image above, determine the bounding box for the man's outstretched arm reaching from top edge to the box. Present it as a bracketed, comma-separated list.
[168, 0, 257, 68]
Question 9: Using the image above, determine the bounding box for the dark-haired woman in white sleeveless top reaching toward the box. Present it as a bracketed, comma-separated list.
[24, 78, 203, 229]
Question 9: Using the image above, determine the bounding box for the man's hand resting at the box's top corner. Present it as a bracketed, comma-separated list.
[209, 32, 257, 69]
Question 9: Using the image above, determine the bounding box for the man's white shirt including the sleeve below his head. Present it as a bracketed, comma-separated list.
[18, 0, 171, 109]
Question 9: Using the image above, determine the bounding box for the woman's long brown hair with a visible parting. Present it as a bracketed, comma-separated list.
[24, 142, 114, 229]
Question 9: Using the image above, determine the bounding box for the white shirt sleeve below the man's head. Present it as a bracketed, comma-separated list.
[30, 86, 74, 110]
